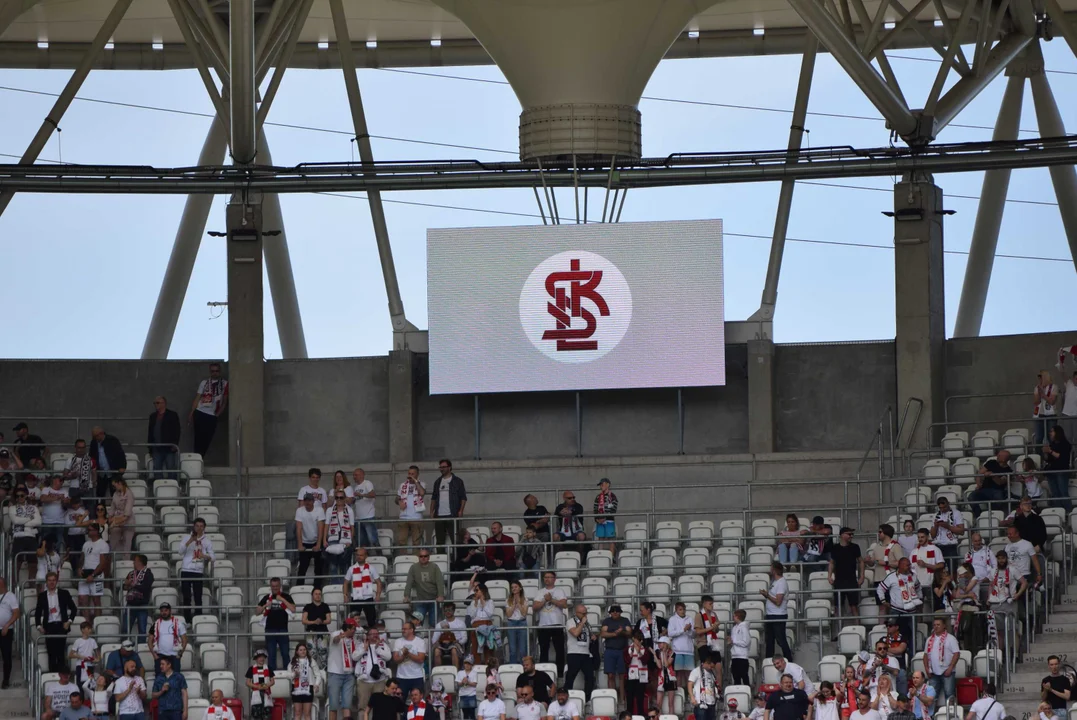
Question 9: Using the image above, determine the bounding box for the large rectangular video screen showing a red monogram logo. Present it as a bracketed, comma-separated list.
[426, 220, 726, 394]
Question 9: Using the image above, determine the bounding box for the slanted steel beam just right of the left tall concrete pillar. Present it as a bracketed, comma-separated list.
[258, 127, 307, 359]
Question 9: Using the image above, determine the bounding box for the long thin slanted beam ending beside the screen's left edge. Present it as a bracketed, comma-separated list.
[330, 0, 407, 333]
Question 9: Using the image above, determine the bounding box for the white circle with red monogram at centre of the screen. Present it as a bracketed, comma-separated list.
[520, 250, 632, 363]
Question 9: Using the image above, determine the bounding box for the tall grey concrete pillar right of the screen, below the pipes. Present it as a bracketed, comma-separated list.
[894, 173, 946, 448]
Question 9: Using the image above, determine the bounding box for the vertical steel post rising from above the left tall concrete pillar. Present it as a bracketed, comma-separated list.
[228, 0, 257, 165]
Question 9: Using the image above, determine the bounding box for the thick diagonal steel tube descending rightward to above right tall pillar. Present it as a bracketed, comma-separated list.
[789, 0, 918, 137]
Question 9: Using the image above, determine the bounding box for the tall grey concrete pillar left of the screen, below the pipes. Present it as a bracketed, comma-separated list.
[225, 196, 265, 466]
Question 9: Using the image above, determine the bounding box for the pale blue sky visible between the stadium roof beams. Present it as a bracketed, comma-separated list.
[0, 40, 1077, 358]
